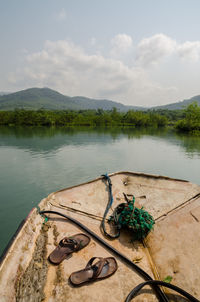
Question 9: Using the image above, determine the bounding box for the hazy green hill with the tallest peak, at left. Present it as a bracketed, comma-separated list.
[0, 88, 142, 111]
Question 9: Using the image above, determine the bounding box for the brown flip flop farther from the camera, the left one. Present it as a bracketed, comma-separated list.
[48, 234, 90, 264]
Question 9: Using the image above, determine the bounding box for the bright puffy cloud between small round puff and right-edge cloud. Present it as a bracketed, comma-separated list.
[137, 34, 176, 66]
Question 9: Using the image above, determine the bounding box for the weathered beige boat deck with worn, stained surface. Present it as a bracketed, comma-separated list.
[0, 172, 200, 302]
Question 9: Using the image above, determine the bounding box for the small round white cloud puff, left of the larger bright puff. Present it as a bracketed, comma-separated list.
[110, 34, 133, 58]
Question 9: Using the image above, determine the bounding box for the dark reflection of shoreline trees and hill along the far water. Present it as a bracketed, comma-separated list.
[0, 127, 200, 156]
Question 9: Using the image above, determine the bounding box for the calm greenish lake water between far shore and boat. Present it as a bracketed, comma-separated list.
[0, 127, 200, 254]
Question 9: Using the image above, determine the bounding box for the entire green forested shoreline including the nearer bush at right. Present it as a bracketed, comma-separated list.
[0, 103, 200, 135]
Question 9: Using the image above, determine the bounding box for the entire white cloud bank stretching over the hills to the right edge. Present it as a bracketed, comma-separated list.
[8, 34, 200, 106]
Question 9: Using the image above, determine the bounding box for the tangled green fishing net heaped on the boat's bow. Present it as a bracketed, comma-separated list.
[109, 196, 155, 240]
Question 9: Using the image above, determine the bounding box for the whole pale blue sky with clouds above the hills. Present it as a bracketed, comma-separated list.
[0, 0, 200, 107]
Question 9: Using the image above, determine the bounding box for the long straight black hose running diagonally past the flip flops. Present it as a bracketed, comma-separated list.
[39, 211, 168, 302]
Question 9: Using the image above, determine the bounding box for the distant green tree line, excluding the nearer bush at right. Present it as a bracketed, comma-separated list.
[0, 108, 168, 127]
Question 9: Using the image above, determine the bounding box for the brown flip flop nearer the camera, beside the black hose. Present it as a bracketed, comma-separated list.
[69, 257, 118, 286]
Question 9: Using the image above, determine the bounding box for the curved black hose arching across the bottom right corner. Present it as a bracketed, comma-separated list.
[125, 280, 199, 302]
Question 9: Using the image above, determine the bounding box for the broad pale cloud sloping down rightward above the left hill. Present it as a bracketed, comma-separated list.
[8, 41, 180, 106]
